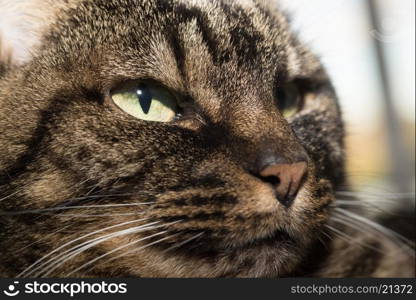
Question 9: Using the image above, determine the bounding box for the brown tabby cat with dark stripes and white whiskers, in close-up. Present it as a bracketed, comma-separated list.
[0, 0, 414, 277]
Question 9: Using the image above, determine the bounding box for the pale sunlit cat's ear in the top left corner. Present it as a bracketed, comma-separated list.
[0, 0, 66, 71]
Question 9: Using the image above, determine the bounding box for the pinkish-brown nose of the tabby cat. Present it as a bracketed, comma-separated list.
[259, 161, 307, 207]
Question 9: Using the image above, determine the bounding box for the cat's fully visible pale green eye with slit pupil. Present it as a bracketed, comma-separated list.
[111, 82, 179, 122]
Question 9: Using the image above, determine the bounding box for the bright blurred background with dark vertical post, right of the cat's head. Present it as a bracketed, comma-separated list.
[280, 0, 416, 205]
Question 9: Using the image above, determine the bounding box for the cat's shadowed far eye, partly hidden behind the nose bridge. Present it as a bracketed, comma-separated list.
[277, 82, 301, 118]
